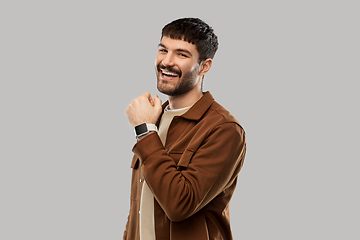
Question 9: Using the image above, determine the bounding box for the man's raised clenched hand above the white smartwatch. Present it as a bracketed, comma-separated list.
[126, 92, 162, 127]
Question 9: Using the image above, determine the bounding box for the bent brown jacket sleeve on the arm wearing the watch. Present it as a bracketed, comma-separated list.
[133, 123, 246, 222]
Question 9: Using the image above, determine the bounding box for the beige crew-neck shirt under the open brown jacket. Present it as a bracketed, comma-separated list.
[140, 107, 190, 240]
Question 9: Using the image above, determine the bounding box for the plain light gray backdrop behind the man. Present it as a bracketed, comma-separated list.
[0, 0, 360, 240]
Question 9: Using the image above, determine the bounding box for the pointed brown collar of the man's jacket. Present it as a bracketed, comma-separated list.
[162, 91, 215, 121]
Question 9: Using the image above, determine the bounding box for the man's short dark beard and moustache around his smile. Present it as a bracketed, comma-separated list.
[156, 64, 199, 97]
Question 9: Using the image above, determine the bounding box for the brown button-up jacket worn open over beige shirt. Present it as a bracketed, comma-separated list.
[124, 92, 246, 240]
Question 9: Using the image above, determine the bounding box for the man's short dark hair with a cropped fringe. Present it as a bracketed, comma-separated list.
[161, 18, 219, 63]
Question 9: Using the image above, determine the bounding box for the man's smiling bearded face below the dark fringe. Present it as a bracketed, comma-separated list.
[155, 36, 201, 96]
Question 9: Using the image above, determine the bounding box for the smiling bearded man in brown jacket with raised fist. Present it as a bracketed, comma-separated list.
[124, 18, 246, 240]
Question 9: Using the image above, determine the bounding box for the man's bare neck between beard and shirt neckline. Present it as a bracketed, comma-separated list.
[169, 88, 203, 109]
